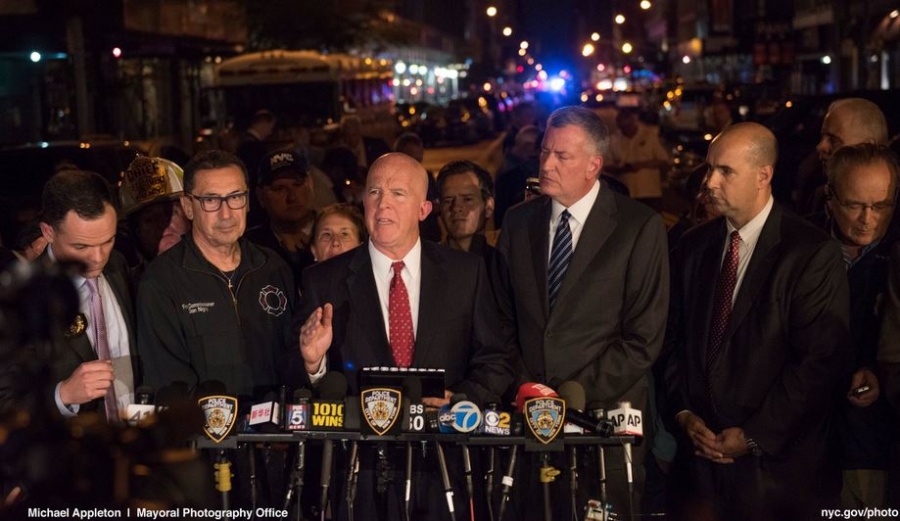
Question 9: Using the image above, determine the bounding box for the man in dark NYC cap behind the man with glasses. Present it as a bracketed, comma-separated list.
[247, 150, 316, 290]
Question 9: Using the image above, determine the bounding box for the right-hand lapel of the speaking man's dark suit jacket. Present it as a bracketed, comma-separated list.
[413, 241, 449, 367]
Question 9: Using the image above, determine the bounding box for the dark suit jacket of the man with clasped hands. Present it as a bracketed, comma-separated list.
[666, 203, 852, 494]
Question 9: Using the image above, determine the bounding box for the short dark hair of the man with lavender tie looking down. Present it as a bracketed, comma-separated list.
[41, 170, 116, 228]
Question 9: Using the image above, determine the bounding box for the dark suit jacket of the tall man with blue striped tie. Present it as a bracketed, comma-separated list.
[492, 183, 669, 409]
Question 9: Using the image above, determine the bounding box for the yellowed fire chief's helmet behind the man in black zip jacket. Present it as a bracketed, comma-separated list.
[119, 156, 184, 218]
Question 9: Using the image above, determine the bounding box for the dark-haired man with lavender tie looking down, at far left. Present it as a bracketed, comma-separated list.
[41, 170, 139, 421]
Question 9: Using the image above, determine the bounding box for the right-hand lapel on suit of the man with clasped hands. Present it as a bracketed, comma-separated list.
[723, 204, 781, 341]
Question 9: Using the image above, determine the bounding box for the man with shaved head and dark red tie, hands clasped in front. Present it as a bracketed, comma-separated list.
[666, 123, 851, 520]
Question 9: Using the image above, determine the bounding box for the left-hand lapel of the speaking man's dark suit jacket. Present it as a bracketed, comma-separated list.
[346, 244, 394, 365]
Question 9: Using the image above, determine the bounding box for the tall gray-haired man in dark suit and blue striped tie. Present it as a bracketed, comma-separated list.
[493, 107, 669, 519]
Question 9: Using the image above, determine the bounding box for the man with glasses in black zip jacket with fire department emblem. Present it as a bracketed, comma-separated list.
[137, 150, 294, 400]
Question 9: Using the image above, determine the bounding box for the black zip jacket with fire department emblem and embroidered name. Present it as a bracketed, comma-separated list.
[137, 236, 296, 396]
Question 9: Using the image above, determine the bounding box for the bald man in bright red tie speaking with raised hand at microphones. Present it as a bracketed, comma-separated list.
[289, 153, 512, 519]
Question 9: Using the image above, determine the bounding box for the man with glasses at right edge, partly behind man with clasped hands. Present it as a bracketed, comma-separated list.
[811, 143, 900, 508]
